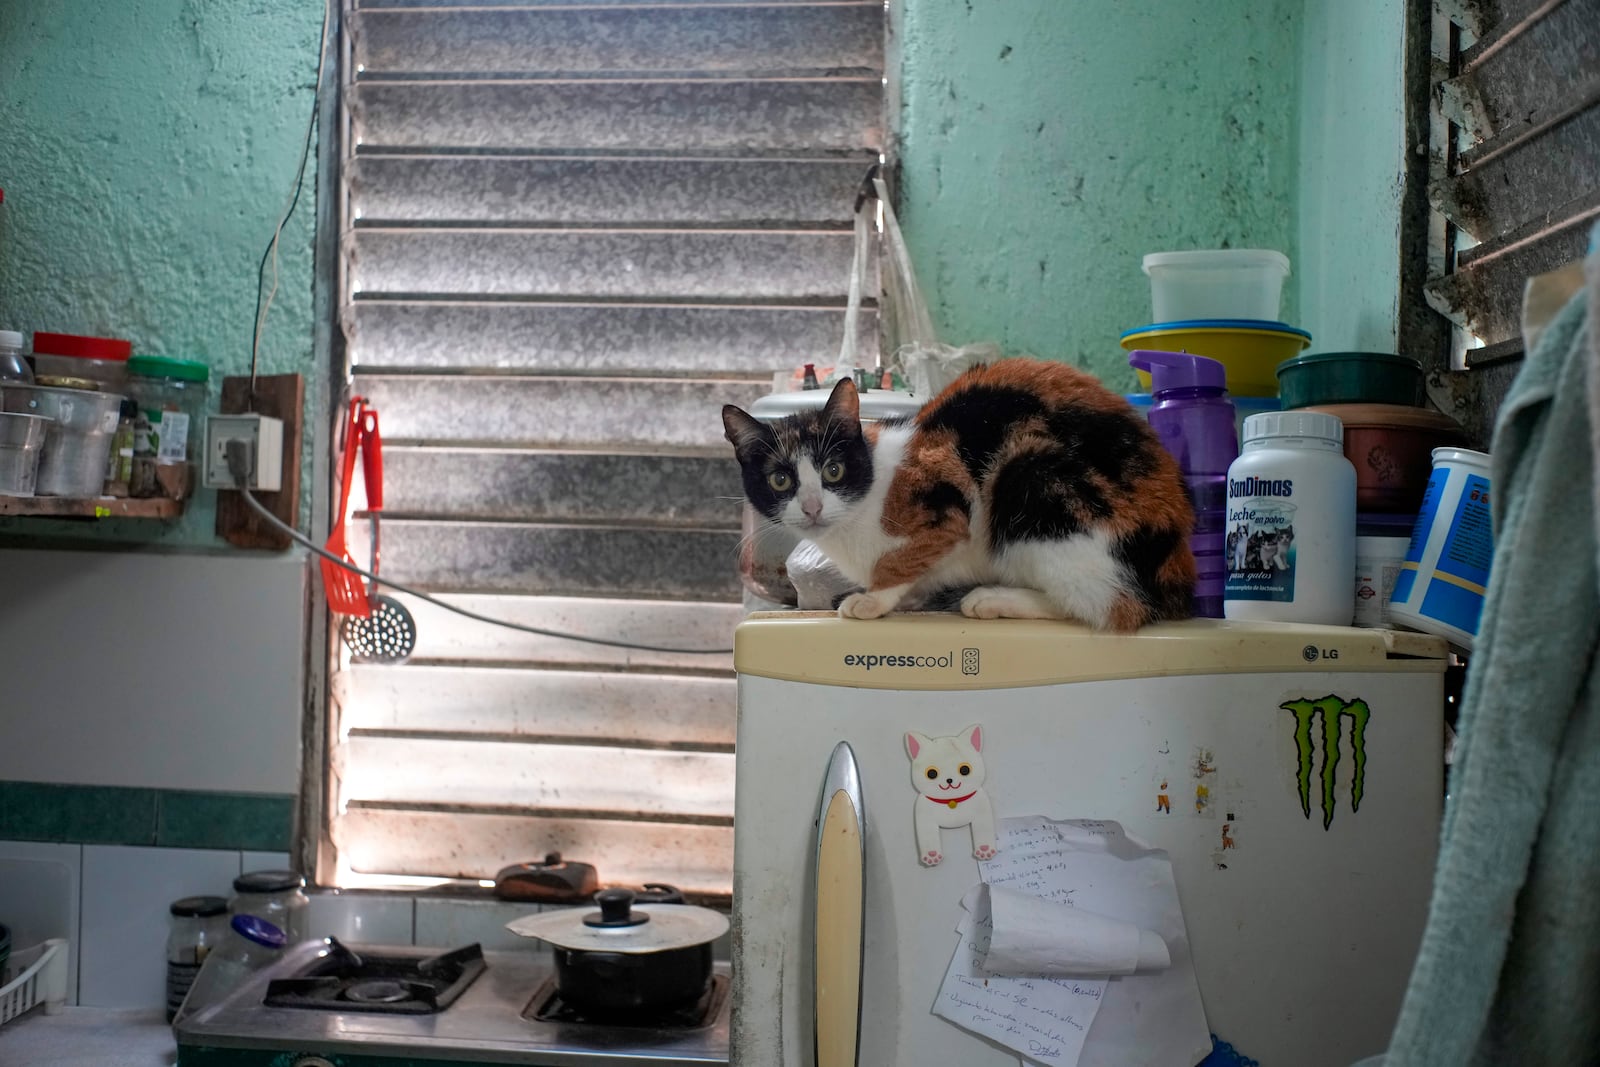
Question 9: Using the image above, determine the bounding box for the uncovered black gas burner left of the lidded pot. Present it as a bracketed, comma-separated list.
[264, 937, 485, 1016]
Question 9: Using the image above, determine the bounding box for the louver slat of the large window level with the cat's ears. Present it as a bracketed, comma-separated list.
[358, 374, 770, 450]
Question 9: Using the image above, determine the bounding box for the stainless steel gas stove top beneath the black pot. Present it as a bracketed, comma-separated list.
[173, 941, 730, 1067]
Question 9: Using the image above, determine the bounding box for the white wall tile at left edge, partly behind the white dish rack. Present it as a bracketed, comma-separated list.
[0, 841, 83, 1005]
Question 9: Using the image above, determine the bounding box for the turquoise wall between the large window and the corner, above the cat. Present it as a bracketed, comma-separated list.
[896, 0, 1315, 387]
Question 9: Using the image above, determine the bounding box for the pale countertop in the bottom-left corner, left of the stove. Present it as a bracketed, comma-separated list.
[0, 1008, 178, 1067]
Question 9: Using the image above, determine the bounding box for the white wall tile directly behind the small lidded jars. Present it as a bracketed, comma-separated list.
[78, 845, 240, 1009]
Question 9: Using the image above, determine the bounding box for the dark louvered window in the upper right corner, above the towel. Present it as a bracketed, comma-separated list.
[1426, 0, 1600, 366]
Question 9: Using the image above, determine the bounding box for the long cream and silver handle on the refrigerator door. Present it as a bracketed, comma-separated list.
[811, 741, 867, 1067]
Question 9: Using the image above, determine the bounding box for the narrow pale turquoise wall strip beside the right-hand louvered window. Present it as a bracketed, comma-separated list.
[1296, 0, 1405, 352]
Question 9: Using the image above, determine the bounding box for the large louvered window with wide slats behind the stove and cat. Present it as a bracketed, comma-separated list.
[328, 0, 883, 894]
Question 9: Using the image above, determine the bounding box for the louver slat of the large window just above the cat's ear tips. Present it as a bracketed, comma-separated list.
[344, 301, 878, 379]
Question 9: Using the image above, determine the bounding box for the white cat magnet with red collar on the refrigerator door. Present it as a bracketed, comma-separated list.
[906, 725, 997, 867]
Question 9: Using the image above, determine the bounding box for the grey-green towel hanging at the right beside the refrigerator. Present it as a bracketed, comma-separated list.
[1373, 293, 1600, 1067]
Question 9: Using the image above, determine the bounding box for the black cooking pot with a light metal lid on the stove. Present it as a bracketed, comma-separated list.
[506, 886, 728, 1017]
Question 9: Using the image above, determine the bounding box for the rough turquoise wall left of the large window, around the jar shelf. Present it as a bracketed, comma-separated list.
[0, 0, 325, 545]
